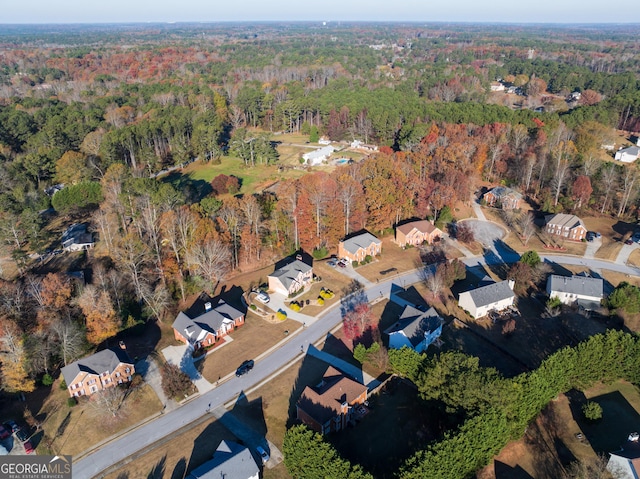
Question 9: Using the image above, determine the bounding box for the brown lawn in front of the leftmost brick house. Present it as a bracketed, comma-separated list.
[35, 381, 162, 456]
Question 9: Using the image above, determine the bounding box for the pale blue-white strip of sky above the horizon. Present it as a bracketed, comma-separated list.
[0, 0, 640, 24]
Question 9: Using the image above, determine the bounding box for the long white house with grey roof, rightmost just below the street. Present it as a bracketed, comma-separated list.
[547, 274, 604, 310]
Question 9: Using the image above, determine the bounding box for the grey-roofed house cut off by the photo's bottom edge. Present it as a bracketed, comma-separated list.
[187, 441, 260, 479]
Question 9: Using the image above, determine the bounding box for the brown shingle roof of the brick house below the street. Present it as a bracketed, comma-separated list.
[298, 366, 367, 424]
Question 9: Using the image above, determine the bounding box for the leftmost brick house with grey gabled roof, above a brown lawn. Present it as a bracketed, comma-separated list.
[61, 349, 135, 397]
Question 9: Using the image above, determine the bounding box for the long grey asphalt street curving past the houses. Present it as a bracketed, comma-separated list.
[73, 249, 640, 479]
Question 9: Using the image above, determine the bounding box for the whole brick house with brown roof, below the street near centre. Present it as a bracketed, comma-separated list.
[296, 366, 367, 434]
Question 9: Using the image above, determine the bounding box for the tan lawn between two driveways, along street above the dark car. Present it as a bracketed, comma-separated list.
[196, 312, 302, 383]
